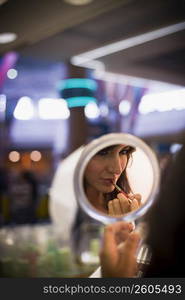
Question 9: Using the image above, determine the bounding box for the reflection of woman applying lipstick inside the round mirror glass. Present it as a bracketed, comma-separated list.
[84, 144, 153, 217]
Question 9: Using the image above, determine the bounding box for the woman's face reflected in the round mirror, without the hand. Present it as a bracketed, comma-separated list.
[85, 145, 131, 193]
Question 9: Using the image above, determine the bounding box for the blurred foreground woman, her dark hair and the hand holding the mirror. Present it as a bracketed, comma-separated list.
[100, 139, 185, 277]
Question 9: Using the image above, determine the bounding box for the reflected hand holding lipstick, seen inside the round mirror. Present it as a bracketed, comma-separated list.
[108, 193, 141, 217]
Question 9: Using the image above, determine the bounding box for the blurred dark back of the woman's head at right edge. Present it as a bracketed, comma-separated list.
[145, 139, 185, 277]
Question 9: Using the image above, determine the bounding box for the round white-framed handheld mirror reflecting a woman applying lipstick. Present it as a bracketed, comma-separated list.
[74, 133, 160, 224]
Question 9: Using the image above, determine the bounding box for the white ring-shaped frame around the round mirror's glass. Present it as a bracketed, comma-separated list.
[73, 133, 160, 224]
